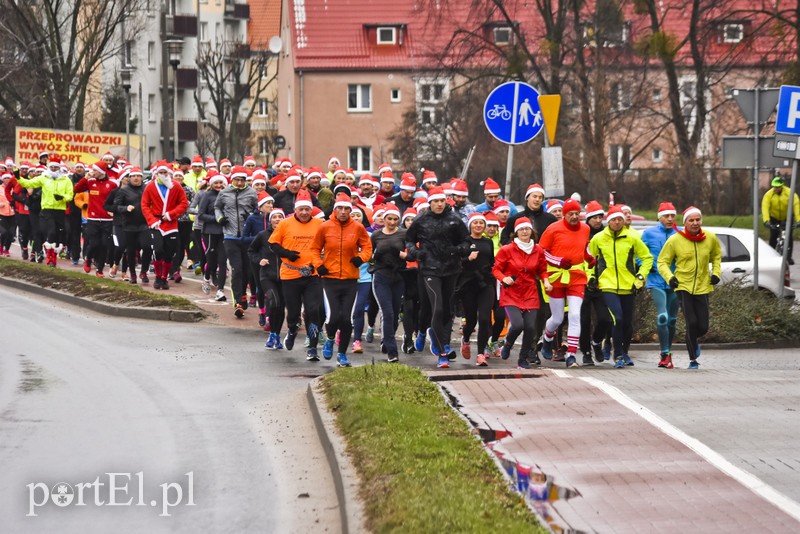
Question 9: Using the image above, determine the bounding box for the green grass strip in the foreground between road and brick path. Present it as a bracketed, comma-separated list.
[323, 365, 546, 533]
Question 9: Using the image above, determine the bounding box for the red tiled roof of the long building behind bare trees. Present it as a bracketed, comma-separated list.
[286, 0, 786, 71]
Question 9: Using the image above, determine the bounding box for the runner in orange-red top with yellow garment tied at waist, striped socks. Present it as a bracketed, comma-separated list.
[539, 199, 594, 367]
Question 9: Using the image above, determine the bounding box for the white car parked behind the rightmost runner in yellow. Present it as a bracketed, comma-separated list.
[703, 226, 794, 299]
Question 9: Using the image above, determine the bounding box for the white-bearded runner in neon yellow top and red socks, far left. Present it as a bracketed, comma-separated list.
[17, 155, 75, 267]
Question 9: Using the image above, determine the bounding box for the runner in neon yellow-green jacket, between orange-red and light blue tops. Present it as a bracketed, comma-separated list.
[588, 206, 653, 369]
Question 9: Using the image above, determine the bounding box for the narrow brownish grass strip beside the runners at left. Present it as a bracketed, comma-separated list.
[0, 258, 200, 311]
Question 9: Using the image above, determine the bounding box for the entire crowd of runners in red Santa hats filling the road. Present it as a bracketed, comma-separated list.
[0, 153, 721, 369]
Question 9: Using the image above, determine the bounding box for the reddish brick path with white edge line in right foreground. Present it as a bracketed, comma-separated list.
[429, 371, 800, 532]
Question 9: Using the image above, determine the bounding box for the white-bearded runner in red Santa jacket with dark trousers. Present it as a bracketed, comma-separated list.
[142, 161, 189, 289]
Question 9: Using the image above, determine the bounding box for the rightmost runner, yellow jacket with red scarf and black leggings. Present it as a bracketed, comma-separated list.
[658, 206, 722, 369]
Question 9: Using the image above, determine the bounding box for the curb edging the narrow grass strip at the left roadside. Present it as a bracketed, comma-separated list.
[0, 278, 205, 323]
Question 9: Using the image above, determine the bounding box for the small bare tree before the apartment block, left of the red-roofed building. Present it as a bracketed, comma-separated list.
[195, 42, 277, 159]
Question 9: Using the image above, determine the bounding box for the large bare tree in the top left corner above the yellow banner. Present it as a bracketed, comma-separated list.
[0, 0, 147, 129]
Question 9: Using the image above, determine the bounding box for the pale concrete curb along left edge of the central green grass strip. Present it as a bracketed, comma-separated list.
[307, 377, 366, 533]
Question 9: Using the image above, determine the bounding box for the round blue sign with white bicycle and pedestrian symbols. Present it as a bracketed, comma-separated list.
[483, 82, 544, 145]
